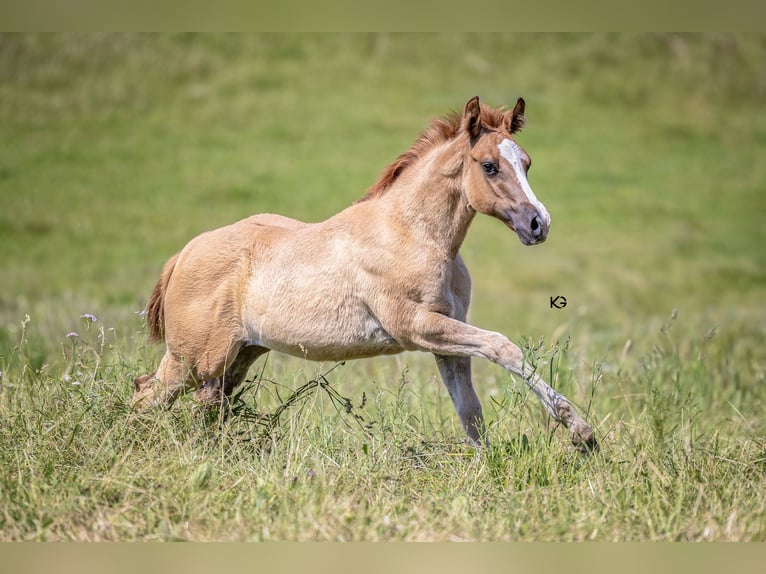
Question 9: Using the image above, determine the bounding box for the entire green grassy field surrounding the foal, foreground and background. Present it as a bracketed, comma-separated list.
[0, 34, 766, 541]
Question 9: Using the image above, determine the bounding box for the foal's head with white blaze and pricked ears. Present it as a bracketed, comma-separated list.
[461, 97, 551, 245]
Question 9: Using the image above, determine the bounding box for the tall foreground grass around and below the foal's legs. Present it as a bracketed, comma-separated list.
[0, 308, 766, 540]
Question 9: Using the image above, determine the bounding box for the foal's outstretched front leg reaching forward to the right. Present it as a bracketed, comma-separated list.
[406, 310, 598, 451]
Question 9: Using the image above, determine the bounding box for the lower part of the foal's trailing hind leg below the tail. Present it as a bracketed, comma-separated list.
[133, 351, 196, 411]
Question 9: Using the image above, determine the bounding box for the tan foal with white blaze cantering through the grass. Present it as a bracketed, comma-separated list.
[133, 97, 598, 452]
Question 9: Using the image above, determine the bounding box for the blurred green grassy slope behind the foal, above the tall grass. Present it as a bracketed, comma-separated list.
[0, 34, 766, 363]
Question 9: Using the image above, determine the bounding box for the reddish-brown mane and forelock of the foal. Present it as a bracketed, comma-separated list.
[357, 104, 506, 203]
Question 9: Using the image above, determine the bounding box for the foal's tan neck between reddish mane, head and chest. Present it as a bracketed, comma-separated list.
[379, 144, 476, 259]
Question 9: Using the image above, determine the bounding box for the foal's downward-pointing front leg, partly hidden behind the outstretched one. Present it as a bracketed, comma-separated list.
[434, 355, 489, 446]
